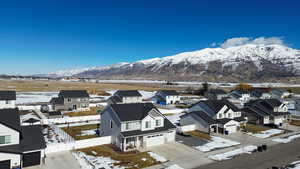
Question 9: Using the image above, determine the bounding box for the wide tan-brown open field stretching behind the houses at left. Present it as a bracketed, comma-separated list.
[0, 80, 185, 95]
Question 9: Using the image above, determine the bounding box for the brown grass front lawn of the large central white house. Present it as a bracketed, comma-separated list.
[77, 145, 160, 169]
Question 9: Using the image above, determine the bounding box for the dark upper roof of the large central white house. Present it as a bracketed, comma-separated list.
[110, 103, 159, 121]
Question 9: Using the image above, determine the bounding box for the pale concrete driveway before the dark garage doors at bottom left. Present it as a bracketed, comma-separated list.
[26, 151, 81, 169]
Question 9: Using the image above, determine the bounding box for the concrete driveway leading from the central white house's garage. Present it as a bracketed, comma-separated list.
[149, 142, 212, 169]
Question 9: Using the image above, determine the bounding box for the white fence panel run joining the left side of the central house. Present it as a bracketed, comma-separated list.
[45, 136, 111, 154]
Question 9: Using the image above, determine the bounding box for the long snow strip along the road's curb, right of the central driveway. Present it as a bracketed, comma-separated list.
[209, 145, 257, 161]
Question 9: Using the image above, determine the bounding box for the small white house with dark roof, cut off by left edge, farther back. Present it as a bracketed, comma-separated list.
[0, 91, 16, 109]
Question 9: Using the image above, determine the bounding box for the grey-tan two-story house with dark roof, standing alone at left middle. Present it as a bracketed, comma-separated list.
[50, 90, 90, 111]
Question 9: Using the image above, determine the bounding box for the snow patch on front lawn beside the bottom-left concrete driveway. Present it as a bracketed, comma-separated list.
[73, 152, 125, 169]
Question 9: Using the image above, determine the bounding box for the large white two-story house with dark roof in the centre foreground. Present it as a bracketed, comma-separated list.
[100, 103, 176, 151]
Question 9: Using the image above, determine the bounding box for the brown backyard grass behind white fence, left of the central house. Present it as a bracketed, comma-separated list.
[61, 124, 98, 140]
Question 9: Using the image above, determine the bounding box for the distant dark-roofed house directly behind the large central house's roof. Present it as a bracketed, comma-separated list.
[107, 90, 143, 105]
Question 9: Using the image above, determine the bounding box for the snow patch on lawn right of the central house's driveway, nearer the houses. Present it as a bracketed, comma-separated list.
[195, 137, 240, 152]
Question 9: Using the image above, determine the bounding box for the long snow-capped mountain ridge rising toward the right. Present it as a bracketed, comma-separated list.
[49, 44, 300, 80]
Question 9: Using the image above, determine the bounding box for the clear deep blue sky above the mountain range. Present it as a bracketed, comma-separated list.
[0, 0, 300, 74]
